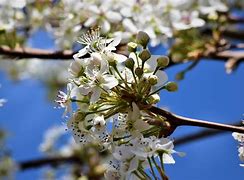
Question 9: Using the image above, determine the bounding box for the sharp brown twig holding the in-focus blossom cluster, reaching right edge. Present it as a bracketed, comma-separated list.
[149, 107, 244, 136]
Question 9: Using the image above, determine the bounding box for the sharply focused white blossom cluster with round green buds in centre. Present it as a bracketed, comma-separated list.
[57, 29, 177, 179]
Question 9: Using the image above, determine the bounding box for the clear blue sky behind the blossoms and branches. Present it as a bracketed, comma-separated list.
[0, 30, 244, 180]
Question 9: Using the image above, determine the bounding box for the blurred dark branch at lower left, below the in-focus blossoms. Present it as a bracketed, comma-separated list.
[18, 156, 81, 170]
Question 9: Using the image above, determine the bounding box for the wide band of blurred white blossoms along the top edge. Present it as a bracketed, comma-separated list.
[0, 0, 228, 49]
